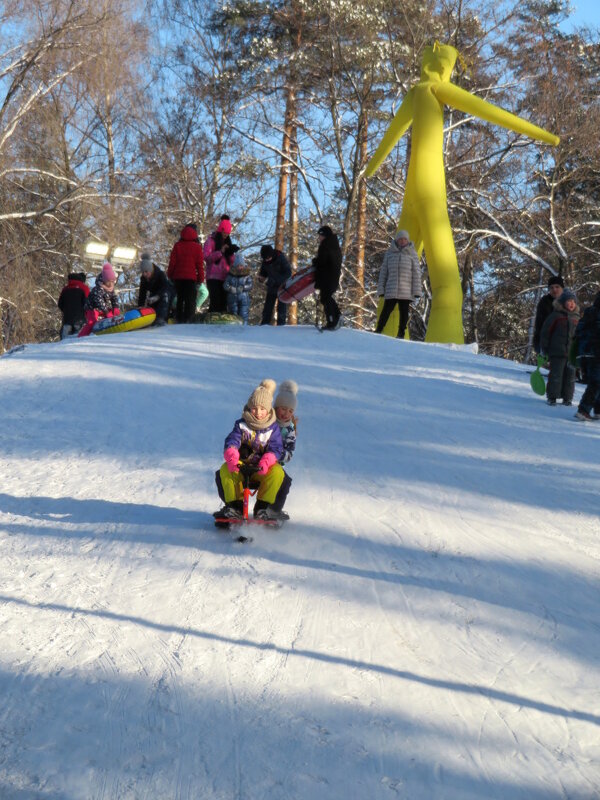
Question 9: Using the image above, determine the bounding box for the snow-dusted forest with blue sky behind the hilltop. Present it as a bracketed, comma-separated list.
[0, 0, 600, 360]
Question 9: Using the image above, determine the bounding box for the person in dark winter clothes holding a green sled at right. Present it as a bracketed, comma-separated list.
[540, 289, 579, 406]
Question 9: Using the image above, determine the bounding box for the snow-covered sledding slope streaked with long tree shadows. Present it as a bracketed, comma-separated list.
[0, 326, 600, 800]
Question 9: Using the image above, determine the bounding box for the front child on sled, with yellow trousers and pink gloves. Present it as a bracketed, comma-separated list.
[215, 378, 291, 520]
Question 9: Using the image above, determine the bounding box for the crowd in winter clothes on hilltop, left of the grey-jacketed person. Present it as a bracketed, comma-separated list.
[58, 214, 342, 338]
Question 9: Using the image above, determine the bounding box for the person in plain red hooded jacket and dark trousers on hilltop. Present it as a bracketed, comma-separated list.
[167, 224, 204, 322]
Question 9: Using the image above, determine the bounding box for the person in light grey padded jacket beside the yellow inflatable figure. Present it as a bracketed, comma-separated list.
[375, 231, 421, 339]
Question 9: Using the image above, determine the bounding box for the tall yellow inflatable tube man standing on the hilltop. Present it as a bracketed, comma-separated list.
[366, 42, 559, 344]
